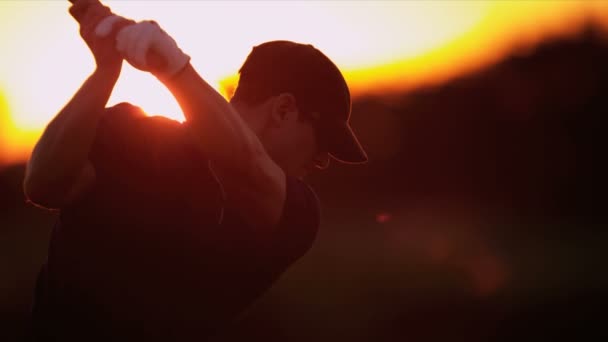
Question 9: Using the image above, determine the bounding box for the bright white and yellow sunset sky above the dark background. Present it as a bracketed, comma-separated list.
[0, 0, 608, 164]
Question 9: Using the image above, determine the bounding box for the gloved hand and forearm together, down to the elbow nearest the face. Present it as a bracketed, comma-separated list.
[111, 21, 263, 171]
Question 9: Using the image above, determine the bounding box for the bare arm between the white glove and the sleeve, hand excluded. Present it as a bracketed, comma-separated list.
[163, 64, 286, 229]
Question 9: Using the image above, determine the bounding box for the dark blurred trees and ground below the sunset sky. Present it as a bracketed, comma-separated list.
[0, 26, 608, 341]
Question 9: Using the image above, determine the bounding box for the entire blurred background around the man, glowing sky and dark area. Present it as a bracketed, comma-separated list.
[0, 0, 608, 341]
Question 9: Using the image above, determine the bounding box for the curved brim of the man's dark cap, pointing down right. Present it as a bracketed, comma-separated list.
[329, 123, 368, 164]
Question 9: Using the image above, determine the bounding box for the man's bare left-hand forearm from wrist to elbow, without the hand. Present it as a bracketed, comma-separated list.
[24, 70, 118, 202]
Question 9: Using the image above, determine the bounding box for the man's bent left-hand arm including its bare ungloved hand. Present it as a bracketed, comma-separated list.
[23, 1, 132, 208]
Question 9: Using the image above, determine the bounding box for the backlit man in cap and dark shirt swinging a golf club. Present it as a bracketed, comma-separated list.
[24, 0, 367, 341]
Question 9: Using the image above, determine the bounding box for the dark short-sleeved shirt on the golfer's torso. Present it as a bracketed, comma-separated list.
[33, 103, 319, 341]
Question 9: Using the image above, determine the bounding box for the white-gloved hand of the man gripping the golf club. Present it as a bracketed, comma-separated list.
[116, 21, 190, 79]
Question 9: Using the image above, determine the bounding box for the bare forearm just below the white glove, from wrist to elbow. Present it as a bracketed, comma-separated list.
[162, 64, 263, 170]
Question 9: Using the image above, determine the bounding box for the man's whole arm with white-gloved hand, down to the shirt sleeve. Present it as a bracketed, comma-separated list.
[117, 21, 286, 232]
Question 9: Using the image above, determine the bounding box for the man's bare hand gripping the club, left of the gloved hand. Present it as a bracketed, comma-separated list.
[70, 0, 135, 75]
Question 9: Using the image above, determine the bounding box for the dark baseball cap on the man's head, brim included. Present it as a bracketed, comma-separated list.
[233, 40, 368, 163]
